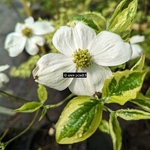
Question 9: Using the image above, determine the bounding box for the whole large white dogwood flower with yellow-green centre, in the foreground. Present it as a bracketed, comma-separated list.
[33, 22, 132, 96]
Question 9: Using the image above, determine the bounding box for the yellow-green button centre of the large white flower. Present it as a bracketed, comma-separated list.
[73, 49, 92, 69]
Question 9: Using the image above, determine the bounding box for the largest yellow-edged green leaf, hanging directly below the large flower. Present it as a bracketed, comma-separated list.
[56, 96, 103, 144]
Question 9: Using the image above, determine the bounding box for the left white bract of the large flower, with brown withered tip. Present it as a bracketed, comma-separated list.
[33, 53, 76, 90]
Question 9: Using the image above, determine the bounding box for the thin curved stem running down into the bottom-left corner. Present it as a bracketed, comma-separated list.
[4, 111, 39, 147]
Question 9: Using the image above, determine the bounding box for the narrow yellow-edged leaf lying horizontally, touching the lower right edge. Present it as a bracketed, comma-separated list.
[116, 109, 150, 120]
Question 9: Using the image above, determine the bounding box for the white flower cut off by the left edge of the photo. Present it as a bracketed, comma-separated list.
[0, 65, 9, 87]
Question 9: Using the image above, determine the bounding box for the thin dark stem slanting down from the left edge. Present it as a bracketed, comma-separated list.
[0, 90, 29, 103]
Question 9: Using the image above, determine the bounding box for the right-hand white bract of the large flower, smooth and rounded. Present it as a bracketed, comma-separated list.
[89, 31, 132, 66]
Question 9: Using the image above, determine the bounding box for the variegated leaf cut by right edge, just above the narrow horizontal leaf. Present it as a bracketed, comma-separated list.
[130, 93, 150, 112]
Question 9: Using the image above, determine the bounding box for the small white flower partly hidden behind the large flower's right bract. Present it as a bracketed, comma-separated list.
[130, 35, 145, 59]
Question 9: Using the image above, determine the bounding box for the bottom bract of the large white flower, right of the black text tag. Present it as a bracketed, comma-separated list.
[69, 64, 112, 96]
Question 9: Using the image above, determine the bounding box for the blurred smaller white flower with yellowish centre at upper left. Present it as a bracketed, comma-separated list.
[4, 17, 54, 57]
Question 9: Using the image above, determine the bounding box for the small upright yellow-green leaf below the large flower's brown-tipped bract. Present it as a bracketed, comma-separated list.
[37, 84, 47, 103]
